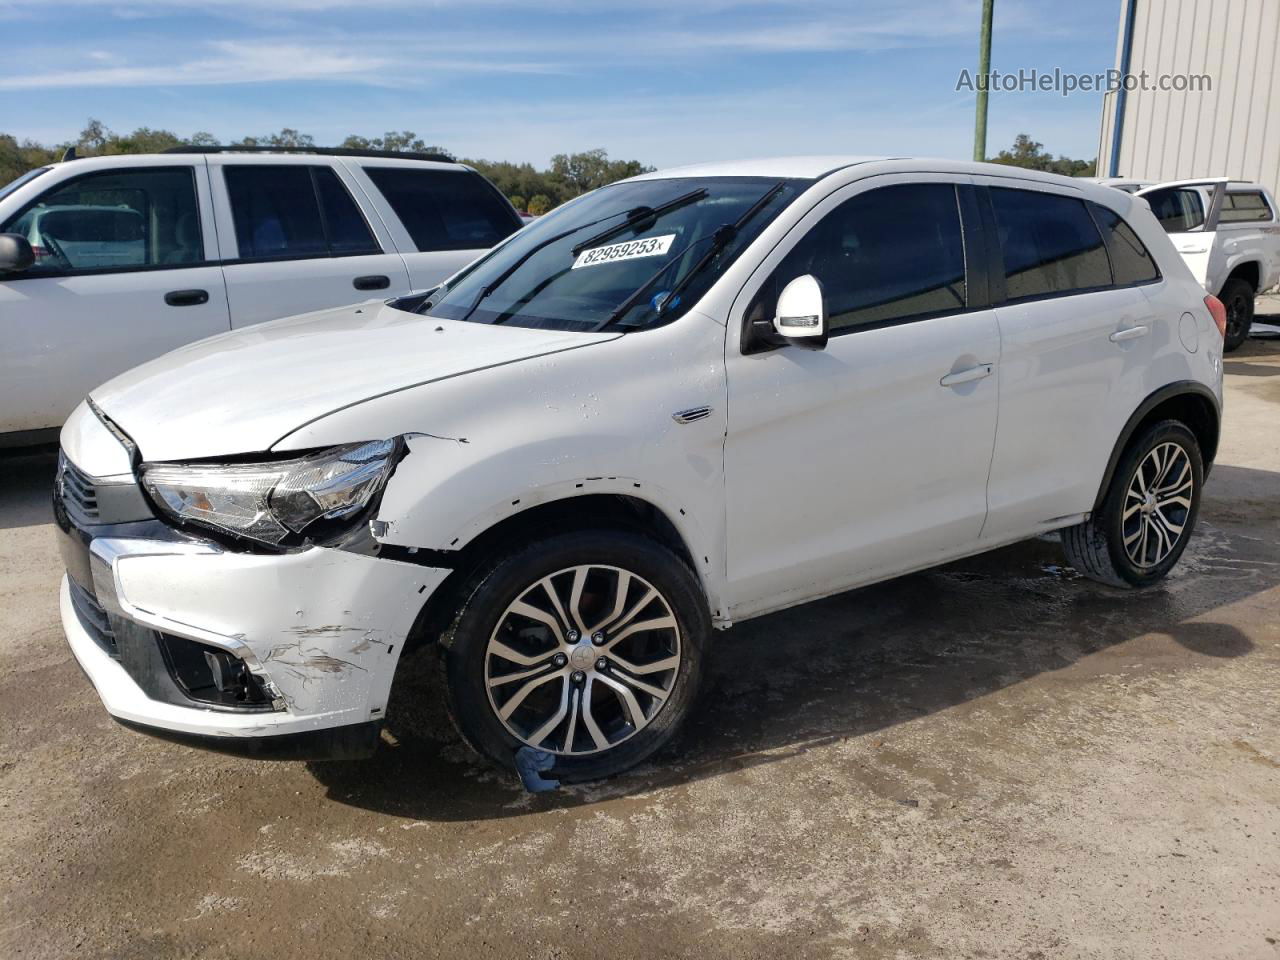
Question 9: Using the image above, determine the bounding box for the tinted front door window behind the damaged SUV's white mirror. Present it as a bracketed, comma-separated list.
[769, 183, 966, 333]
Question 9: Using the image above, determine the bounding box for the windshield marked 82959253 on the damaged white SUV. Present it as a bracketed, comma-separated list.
[421, 177, 810, 332]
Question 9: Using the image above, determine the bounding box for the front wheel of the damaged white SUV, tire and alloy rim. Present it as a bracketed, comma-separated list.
[442, 530, 710, 781]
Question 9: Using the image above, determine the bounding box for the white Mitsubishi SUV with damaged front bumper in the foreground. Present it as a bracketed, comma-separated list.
[56, 157, 1225, 780]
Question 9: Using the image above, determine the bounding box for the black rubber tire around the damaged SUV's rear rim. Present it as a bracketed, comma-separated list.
[1060, 420, 1204, 588]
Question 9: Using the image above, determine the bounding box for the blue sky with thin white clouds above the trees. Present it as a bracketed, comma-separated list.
[0, 0, 1120, 166]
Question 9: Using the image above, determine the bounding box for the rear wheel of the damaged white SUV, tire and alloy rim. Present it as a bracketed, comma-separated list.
[1060, 420, 1204, 586]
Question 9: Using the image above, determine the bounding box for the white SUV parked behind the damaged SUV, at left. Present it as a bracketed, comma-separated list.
[0, 147, 522, 445]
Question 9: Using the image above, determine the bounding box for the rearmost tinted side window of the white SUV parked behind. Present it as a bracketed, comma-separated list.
[365, 166, 521, 251]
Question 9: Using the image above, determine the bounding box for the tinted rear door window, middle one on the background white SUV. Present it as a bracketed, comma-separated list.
[223, 164, 381, 260]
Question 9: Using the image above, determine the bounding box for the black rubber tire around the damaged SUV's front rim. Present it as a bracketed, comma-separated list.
[442, 530, 710, 782]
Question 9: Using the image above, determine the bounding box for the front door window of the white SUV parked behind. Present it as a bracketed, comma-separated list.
[0, 166, 205, 276]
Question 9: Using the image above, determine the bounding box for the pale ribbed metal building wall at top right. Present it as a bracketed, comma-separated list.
[1098, 0, 1280, 195]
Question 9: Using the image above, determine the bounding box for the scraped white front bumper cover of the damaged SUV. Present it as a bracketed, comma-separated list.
[60, 535, 449, 759]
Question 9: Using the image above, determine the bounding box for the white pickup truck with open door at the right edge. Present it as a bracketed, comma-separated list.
[1137, 177, 1280, 352]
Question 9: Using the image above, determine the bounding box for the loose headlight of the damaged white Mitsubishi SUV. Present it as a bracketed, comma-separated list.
[142, 440, 399, 545]
